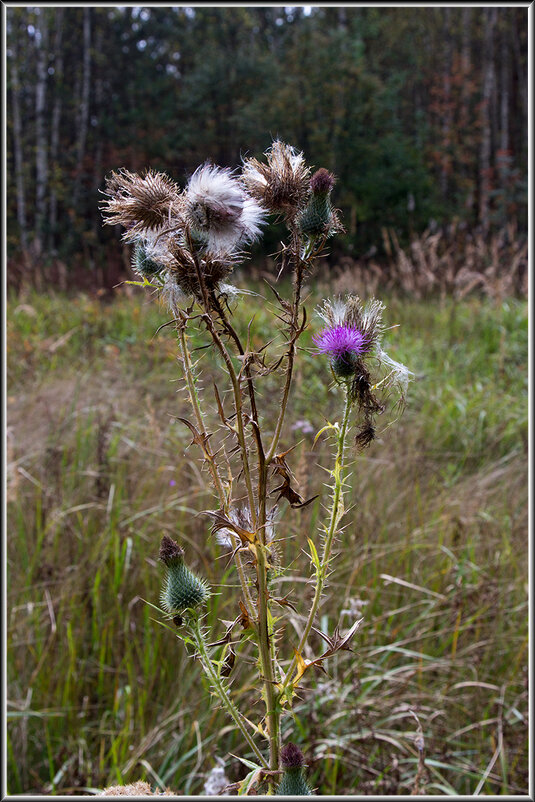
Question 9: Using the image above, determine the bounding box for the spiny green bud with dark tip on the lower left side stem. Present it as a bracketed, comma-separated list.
[160, 535, 210, 615]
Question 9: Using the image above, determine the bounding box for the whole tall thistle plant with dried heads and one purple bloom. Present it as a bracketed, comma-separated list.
[103, 140, 410, 795]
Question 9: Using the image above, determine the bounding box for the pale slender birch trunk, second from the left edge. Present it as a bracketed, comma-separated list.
[34, 8, 48, 257]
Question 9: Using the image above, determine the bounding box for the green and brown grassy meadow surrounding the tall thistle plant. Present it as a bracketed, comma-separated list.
[7, 276, 528, 795]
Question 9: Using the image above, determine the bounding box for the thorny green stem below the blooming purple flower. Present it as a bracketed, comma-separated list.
[283, 393, 352, 690]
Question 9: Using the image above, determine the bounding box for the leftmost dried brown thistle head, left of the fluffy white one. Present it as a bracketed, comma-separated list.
[102, 169, 183, 241]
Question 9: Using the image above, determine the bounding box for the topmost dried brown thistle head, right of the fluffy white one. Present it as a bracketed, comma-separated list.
[242, 139, 310, 217]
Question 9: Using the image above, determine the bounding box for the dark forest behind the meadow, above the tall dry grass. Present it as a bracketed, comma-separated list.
[6, 6, 528, 288]
